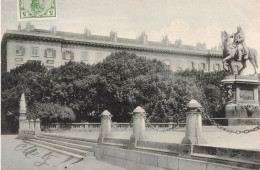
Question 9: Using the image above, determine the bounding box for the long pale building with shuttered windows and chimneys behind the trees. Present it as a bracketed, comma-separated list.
[1, 23, 233, 72]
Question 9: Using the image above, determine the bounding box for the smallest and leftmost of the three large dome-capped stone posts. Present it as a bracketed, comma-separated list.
[98, 110, 112, 144]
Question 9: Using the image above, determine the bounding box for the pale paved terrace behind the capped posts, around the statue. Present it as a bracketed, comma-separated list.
[49, 126, 260, 151]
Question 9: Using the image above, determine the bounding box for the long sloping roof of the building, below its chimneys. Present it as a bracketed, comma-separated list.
[3, 29, 222, 57]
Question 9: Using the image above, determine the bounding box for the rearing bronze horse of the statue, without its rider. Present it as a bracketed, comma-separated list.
[221, 31, 258, 75]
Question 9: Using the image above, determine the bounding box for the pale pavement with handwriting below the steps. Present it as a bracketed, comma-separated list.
[1, 135, 126, 170]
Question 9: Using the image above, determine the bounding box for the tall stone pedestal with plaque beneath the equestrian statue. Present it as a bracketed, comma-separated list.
[222, 75, 260, 126]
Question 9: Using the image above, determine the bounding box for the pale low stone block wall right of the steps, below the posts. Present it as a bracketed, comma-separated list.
[94, 145, 251, 170]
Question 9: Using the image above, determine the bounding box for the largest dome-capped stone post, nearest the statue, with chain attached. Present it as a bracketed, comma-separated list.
[181, 100, 206, 144]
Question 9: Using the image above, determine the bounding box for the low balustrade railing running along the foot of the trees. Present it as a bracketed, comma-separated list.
[41, 122, 185, 132]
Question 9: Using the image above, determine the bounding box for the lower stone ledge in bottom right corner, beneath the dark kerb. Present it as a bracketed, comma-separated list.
[191, 153, 260, 169]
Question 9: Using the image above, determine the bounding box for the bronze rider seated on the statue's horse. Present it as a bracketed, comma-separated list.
[230, 26, 248, 61]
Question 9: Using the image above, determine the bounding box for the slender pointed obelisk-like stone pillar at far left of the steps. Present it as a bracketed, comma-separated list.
[19, 93, 26, 133]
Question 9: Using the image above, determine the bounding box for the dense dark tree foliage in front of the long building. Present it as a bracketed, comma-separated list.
[2, 51, 230, 126]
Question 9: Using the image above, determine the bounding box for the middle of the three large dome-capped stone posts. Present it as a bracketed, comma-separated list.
[129, 106, 146, 149]
